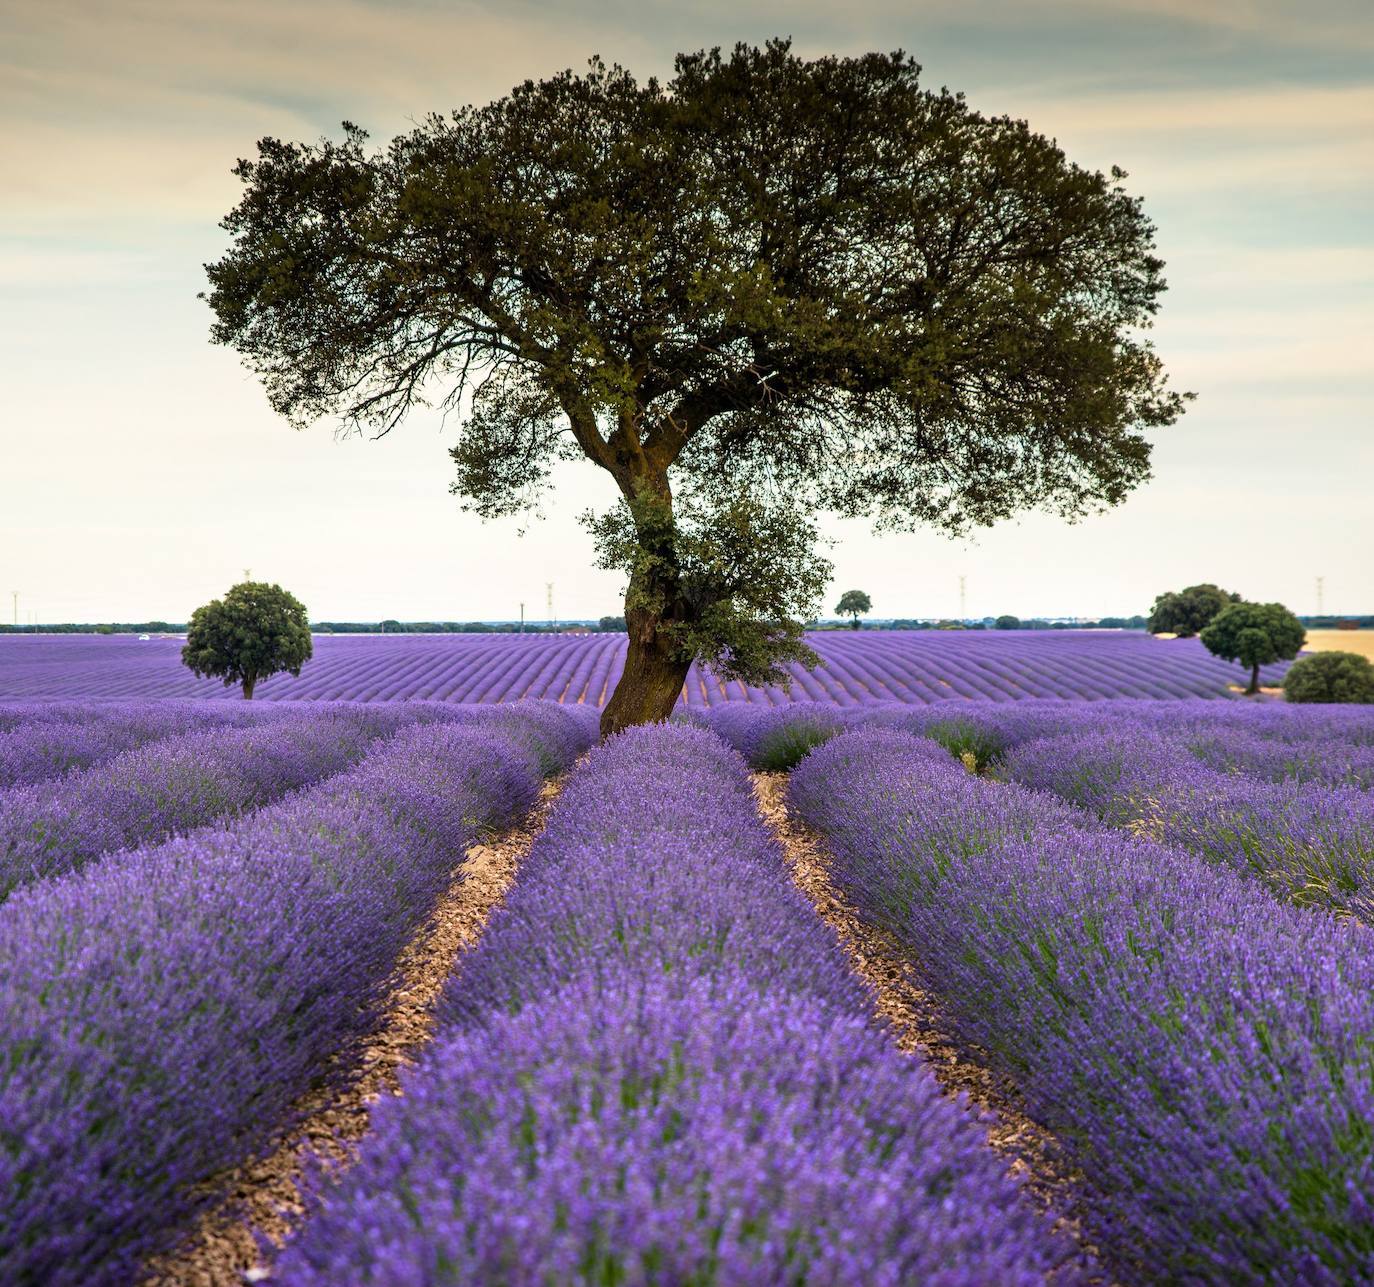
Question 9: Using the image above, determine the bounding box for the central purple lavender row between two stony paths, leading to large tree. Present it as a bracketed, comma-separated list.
[273, 727, 1062, 1287]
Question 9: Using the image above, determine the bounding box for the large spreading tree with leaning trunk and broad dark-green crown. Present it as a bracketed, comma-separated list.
[206, 41, 1184, 731]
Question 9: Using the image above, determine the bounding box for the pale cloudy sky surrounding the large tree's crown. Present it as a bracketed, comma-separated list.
[0, 0, 1374, 622]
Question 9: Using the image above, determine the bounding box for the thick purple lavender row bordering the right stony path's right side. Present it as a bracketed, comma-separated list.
[790, 729, 1374, 1283]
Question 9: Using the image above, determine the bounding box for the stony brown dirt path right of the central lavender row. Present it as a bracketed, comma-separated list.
[752, 773, 1107, 1283]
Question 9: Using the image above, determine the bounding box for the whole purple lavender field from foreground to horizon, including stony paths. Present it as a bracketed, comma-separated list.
[0, 678, 1374, 1287]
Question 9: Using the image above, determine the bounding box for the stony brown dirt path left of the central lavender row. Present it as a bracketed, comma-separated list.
[143, 777, 563, 1287]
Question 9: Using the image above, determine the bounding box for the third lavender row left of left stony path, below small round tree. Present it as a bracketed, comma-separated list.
[0, 702, 289, 788]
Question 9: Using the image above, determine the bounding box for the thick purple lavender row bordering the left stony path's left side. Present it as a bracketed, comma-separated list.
[0, 711, 587, 1287]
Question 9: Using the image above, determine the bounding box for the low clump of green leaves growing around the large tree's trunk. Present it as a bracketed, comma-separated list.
[583, 492, 830, 688]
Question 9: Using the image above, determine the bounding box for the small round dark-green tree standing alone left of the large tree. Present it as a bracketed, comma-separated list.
[181, 581, 312, 701]
